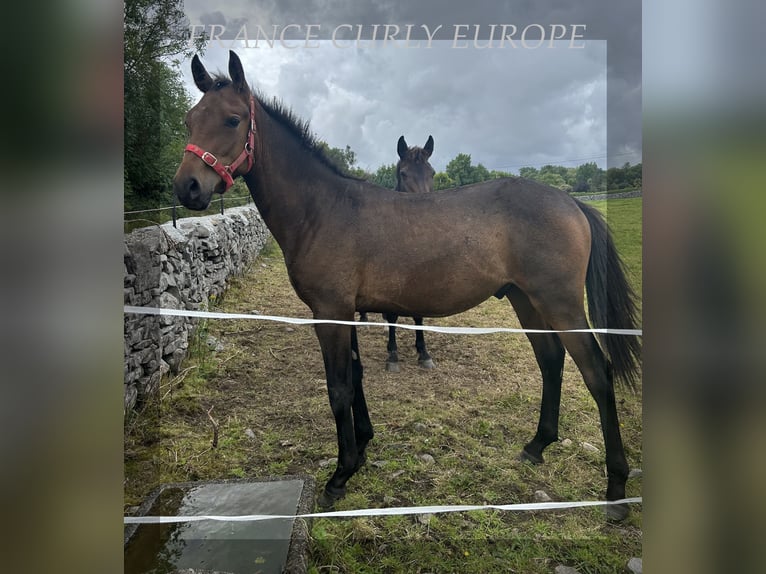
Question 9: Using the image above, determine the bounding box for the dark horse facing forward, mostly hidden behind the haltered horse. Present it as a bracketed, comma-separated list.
[383, 135, 435, 373]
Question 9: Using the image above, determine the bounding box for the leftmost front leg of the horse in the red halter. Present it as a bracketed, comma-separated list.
[315, 324, 369, 507]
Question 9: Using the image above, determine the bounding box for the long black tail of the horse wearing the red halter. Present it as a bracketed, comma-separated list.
[575, 200, 641, 390]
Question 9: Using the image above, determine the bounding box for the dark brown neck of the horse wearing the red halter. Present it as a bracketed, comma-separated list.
[244, 111, 348, 256]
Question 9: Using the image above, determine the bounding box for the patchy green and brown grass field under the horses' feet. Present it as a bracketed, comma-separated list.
[125, 198, 642, 574]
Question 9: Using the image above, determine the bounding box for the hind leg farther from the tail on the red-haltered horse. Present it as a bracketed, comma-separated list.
[507, 287, 564, 464]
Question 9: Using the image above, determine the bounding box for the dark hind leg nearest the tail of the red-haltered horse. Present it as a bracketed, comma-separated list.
[559, 328, 629, 520]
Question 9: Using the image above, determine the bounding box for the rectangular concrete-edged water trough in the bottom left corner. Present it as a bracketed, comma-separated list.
[124, 476, 315, 574]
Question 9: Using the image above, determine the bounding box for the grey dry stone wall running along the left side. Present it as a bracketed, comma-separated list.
[124, 205, 269, 414]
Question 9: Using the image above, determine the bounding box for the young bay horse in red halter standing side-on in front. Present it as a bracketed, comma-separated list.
[173, 52, 641, 520]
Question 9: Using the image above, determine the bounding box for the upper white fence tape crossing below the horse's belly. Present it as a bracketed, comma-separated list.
[124, 305, 642, 336]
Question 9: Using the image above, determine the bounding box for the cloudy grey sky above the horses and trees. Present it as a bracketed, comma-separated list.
[182, 0, 641, 173]
